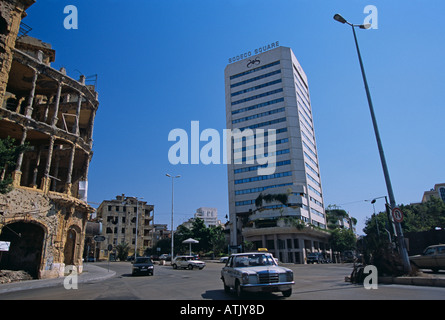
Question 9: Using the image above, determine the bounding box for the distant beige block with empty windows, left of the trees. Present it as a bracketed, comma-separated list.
[94, 194, 154, 260]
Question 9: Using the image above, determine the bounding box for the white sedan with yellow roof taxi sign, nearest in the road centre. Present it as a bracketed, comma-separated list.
[221, 252, 294, 297]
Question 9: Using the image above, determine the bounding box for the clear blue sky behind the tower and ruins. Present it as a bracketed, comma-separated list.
[23, 0, 445, 233]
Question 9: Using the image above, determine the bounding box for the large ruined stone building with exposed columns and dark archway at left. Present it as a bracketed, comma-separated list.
[0, 0, 99, 278]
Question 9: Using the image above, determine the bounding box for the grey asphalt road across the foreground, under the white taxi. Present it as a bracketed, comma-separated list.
[0, 262, 445, 301]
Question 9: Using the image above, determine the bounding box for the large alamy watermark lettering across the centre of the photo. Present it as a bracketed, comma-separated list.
[168, 121, 277, 175]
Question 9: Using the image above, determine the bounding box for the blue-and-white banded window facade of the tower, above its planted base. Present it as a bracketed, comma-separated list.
[225, 47, 326, 250]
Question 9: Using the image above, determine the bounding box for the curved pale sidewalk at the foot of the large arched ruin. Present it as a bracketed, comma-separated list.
[0, 263, 116, 299]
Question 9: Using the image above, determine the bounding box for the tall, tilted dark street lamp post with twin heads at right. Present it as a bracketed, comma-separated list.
[334, 13, 411, 273]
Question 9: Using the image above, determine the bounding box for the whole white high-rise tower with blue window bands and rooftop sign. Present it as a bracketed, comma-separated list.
[225, 46, 327, 262]
